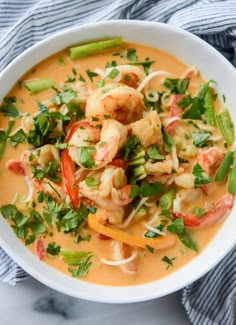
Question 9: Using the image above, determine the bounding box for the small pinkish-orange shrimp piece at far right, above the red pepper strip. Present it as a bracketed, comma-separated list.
[197, 148, 224, 175]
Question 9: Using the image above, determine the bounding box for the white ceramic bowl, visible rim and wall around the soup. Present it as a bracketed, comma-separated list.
[0, 20, 236, 303]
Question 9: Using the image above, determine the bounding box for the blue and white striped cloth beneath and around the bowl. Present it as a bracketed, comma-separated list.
[0, 0, 236, 325]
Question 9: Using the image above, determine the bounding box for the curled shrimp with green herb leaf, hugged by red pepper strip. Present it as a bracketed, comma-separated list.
[68, 120, 127, 170]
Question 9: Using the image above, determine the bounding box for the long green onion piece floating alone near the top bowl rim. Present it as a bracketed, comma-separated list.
[69, 38, 123, 60]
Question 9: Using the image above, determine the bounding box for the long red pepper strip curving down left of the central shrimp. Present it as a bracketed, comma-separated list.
[61, 120, 89, 208]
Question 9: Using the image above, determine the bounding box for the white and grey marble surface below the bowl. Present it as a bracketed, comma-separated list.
[0, 279, 190, 325]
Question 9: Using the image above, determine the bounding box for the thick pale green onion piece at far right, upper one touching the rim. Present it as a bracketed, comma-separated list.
[216, 109, 234, 144]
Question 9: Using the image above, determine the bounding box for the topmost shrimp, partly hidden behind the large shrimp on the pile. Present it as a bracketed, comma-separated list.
[104, 64, 146, 88]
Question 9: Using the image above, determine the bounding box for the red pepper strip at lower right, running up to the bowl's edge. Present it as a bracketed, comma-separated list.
[173, 193, 234, 228]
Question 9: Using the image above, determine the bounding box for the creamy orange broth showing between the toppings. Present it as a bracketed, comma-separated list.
[0, 44, 232, 286]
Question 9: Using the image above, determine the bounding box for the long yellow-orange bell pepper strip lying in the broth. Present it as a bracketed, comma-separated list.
[88, 214, 176, 249]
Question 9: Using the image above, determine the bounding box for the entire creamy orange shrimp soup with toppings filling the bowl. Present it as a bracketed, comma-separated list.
[0, 40, 236, 286]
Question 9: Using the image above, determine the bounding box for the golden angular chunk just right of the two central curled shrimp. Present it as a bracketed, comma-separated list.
[129, 111, 163, 148]
